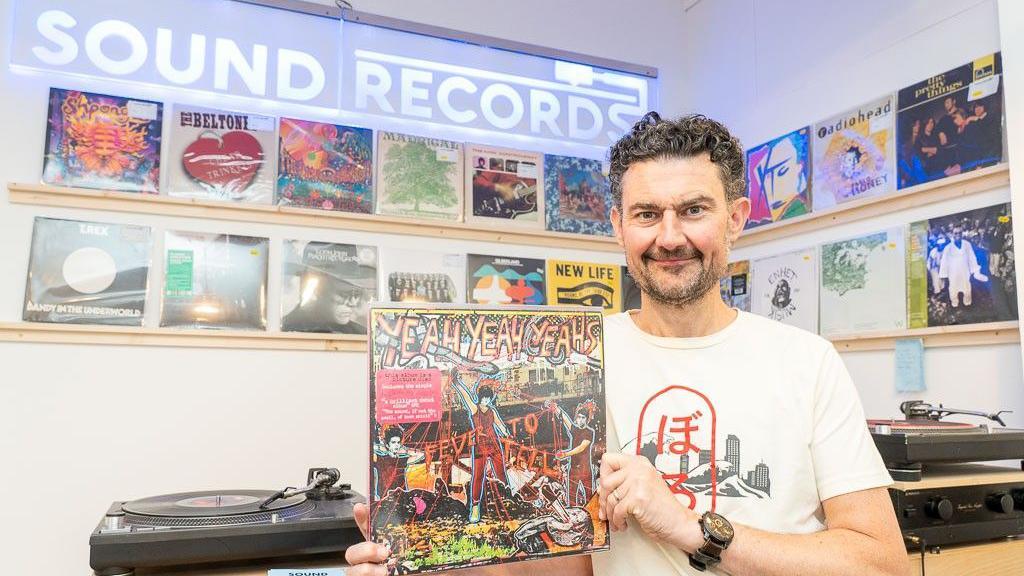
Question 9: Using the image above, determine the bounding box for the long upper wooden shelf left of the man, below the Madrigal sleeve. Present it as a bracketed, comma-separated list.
[7, 182, 621, 252]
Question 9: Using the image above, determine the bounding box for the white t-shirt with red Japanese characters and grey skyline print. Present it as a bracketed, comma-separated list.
[594, 312, 892, 576]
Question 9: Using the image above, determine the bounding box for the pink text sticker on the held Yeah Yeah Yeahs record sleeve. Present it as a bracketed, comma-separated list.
[374, 368, 441, 425]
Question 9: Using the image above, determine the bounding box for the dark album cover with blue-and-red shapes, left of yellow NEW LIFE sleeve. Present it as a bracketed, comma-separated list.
[466, 254, 547, 304]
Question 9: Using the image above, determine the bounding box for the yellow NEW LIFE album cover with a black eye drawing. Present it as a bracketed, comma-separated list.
[547, 260, 623, 314]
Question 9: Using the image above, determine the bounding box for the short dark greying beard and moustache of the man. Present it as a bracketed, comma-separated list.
[629, 242, 726, 306]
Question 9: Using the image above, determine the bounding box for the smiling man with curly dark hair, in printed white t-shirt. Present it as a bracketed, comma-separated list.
[346, 114, 908, 576]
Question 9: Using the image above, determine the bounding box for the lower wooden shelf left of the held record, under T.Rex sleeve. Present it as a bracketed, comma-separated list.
[0, 322, 367, 352]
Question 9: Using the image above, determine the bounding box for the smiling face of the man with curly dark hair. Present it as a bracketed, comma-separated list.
[611, 154, 751, 305]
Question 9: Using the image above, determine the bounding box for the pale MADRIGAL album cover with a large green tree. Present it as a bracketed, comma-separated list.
[377, 131, 465, 220]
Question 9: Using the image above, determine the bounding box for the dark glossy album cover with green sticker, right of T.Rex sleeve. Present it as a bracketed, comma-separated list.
[160, 232, 269, 330]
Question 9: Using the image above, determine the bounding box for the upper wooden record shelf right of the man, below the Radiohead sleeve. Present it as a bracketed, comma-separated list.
[733, 164, 1010, 248]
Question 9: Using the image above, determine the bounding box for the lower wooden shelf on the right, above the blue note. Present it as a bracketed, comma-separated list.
[828, 321, 1021, 352]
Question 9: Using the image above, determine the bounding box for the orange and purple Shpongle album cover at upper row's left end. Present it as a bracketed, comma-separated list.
[43, 88, 164, 194]
